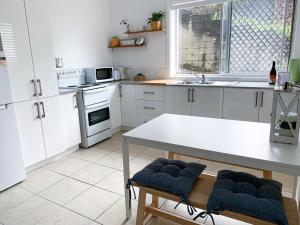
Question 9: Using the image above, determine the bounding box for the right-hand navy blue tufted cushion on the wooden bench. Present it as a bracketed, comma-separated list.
[207, 170, 288, 225]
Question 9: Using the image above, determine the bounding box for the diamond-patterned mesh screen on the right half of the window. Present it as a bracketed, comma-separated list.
[229, 0, 294, 73]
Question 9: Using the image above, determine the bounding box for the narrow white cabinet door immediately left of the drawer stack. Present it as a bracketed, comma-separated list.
[121, 85, 136, 127]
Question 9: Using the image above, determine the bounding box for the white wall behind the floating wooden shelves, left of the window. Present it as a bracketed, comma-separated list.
[111, 0, 168, 79]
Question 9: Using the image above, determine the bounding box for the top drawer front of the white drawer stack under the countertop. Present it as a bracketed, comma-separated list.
[136, 85, 165, 102]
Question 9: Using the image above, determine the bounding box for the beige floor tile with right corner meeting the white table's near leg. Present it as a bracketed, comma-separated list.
[65, 187, 121, 220]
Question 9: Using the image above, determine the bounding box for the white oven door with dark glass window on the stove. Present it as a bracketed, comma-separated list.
[84, 102, 111, 137]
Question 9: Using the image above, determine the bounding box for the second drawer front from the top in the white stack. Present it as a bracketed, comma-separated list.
[136, 100, 165, 116]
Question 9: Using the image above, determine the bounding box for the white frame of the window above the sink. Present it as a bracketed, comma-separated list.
[166, 0, 300, 78]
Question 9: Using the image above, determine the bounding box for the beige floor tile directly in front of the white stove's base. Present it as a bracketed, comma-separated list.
[70, 149, 111, 162]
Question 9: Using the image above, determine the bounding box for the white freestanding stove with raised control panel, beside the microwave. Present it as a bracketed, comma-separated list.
[57, 69, 112, 148]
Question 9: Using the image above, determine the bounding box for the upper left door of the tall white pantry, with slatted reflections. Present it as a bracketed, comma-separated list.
[0, 0, 36, 102]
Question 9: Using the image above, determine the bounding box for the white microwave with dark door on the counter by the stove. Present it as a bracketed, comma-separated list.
[84, 67, 114, 83]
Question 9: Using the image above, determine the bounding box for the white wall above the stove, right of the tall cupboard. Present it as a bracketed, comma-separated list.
[48, 0, 113, 68]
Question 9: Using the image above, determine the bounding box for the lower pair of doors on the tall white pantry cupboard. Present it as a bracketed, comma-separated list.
[16, 96, 65, 167]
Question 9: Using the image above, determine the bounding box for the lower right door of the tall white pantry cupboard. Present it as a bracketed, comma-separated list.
[39, 96, 65, 158]
